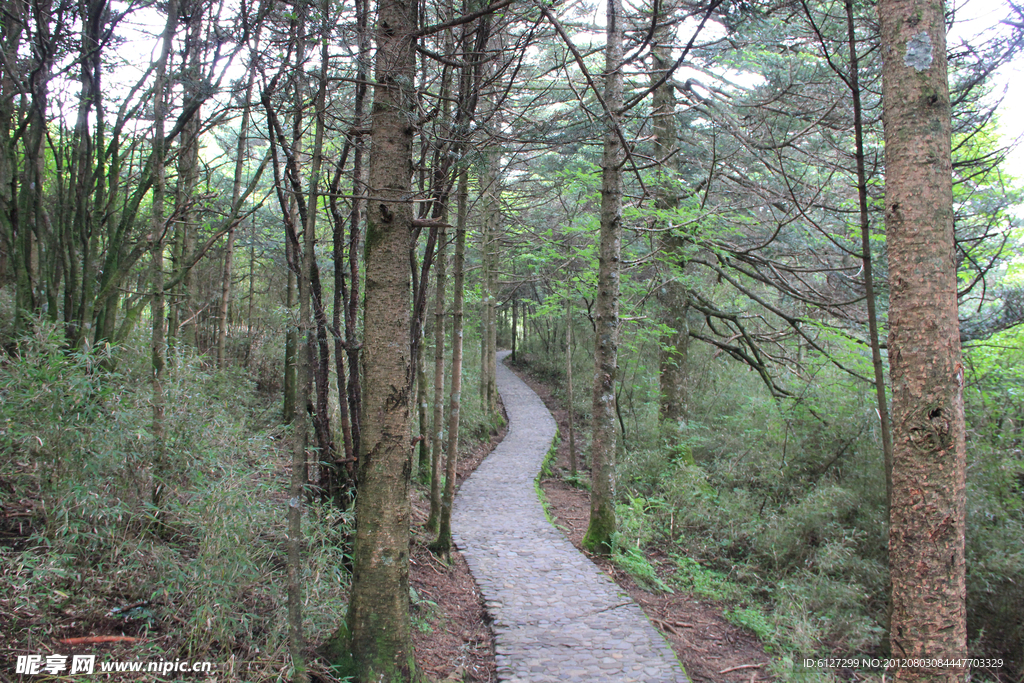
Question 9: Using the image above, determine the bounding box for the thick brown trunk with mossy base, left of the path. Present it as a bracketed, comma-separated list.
[339, 0, 417, 683]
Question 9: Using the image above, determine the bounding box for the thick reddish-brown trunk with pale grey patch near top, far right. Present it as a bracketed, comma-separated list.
[879, 0, 967, 683]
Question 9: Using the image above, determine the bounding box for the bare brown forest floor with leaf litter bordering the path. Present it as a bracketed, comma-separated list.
[0, 358, 769, 683]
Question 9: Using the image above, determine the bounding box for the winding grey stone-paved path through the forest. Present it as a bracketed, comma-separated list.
[453, 354, 686, 683]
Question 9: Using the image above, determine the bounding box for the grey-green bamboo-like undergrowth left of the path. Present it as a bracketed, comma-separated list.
[0, 326, 351, 680]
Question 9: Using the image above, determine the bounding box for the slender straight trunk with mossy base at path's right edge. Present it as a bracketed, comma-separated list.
[583, 0, 624, 553]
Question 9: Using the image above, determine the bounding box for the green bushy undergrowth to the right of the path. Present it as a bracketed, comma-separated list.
[523, 325, 1024, 681]
